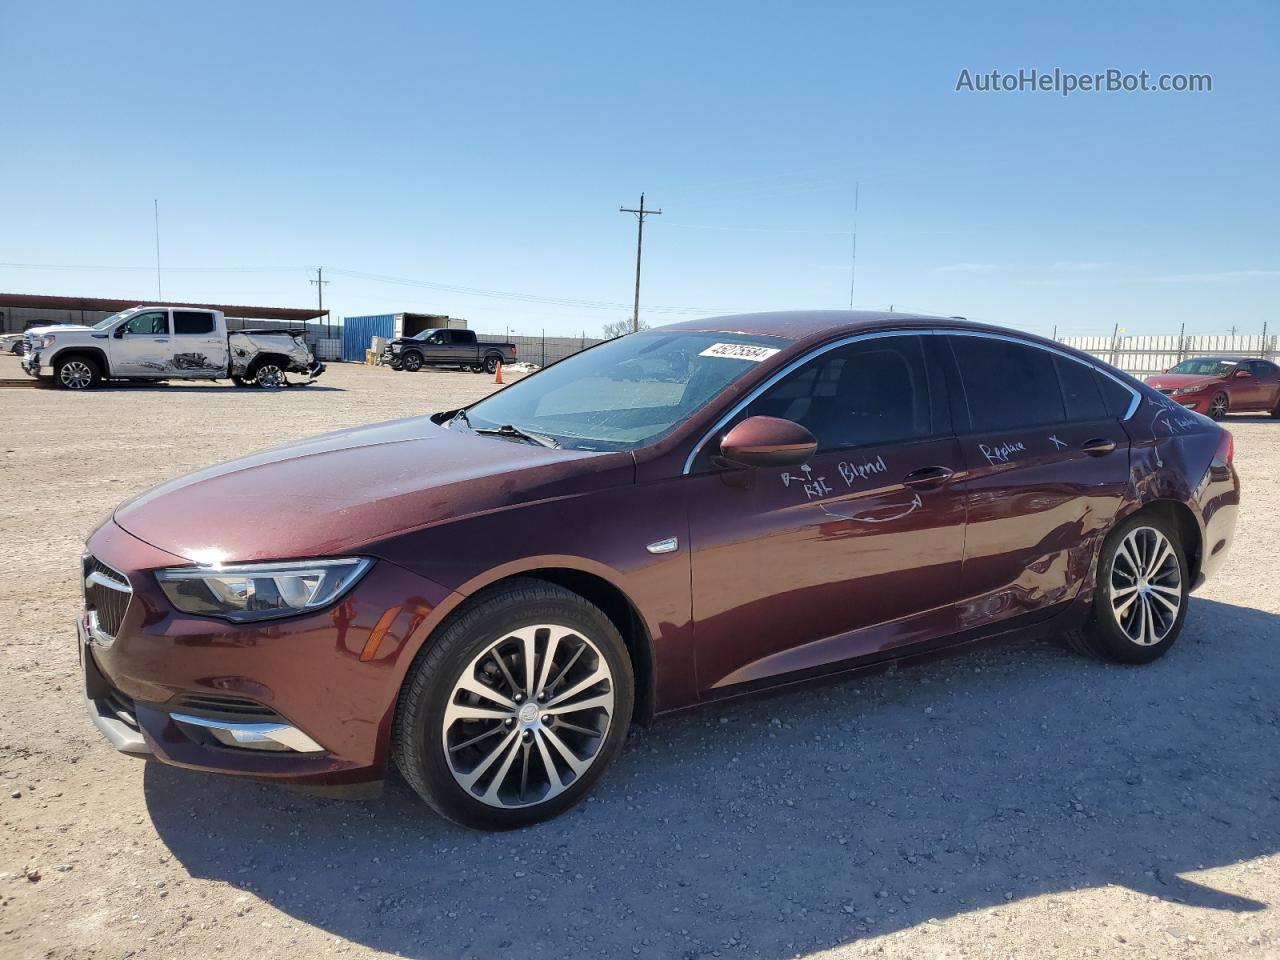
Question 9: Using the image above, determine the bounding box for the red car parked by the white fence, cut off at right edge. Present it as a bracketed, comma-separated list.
[1147, 357, 1280, 420]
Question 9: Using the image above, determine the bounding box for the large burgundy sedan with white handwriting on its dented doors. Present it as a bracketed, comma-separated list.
[79, 312, 1239, 828]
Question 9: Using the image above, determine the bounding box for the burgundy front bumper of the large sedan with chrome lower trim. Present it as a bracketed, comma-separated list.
[77, 521, 451, 785]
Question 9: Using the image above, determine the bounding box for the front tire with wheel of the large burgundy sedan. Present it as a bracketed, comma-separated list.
[392, 579, 635, 829]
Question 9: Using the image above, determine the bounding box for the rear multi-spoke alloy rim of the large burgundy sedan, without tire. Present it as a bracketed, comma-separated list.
[1110, 526, 1183, 646]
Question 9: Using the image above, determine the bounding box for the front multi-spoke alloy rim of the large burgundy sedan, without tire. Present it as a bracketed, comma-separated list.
[442, 623, 614, 809]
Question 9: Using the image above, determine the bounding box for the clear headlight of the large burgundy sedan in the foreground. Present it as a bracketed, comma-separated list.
[156, 557, 372, 622]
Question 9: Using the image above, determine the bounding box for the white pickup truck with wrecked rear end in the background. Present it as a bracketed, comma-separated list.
[22, 306, 324, 390]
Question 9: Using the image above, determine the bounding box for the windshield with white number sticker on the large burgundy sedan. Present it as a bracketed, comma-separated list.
[467, 330, 790, 451]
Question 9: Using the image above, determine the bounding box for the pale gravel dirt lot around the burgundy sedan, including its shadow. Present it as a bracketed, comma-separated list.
[0, 357, 1280, 960]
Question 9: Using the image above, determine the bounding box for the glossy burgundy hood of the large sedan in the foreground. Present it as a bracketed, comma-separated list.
[114, 417, 635, 563]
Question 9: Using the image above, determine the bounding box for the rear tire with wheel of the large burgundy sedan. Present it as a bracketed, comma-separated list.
[1068, 511, 1190, 663]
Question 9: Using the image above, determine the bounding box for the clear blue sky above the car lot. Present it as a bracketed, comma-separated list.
[0, 0, 1280, 334]
